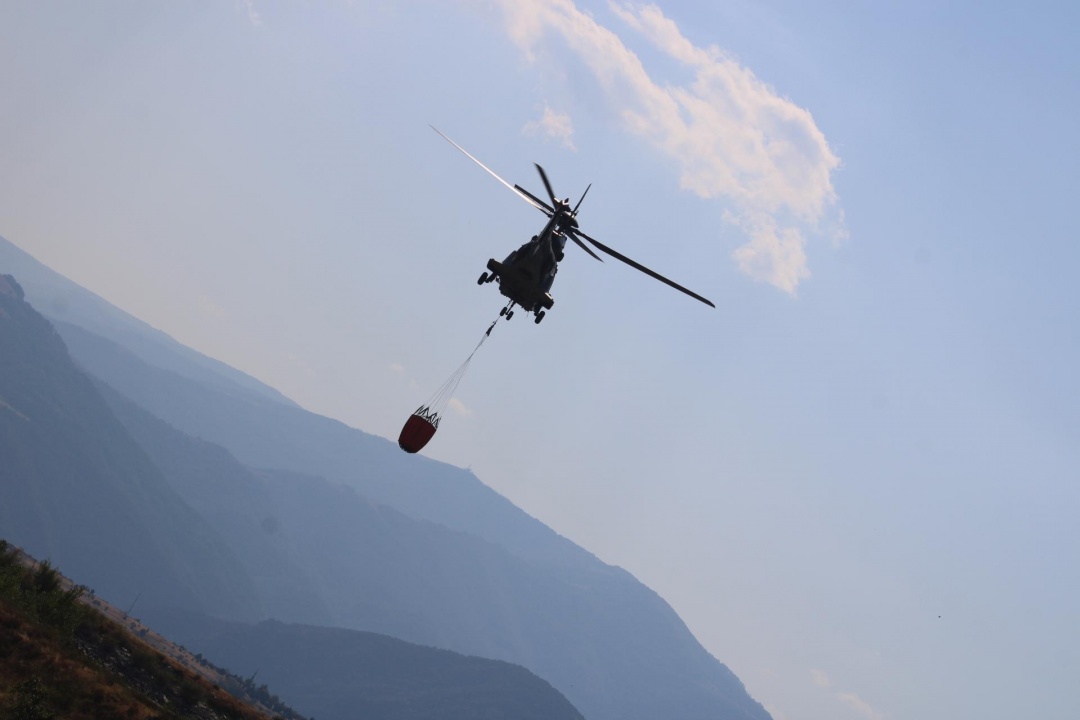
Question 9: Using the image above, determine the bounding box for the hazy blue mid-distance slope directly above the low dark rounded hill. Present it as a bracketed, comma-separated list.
[257, 471, 768, 720]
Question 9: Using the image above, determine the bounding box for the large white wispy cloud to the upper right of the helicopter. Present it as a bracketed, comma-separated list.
[481, 0, 845, 294]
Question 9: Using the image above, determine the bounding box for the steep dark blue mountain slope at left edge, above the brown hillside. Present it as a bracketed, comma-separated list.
[0, 275, 261, 619]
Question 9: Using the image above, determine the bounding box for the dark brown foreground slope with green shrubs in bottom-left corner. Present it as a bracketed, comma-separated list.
[0, 540, 300, 720]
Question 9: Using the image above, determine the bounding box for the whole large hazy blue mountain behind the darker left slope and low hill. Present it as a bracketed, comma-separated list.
[0, 232, 769, 720]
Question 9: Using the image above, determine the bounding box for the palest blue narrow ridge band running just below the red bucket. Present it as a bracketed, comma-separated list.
[55, 322, 596, 567]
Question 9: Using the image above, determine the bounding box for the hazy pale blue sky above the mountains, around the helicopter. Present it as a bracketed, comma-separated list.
[0, 0, 1080, 720]
